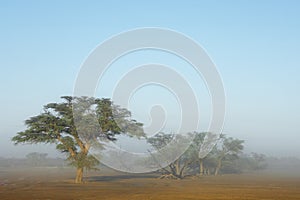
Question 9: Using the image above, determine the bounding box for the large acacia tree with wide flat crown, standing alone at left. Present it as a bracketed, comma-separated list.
[12, 96, 143, 183]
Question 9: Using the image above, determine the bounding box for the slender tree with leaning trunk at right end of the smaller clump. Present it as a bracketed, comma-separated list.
[215, 135, 244, 175]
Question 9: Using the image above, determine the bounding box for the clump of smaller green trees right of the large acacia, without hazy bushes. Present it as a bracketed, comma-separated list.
[147, 132, 248, 178]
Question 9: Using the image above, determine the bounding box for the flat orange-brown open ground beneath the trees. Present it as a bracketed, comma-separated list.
[0, 168, 300, 200]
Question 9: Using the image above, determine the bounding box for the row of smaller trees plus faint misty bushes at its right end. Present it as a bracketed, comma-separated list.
[148, 132, 267, 179]
